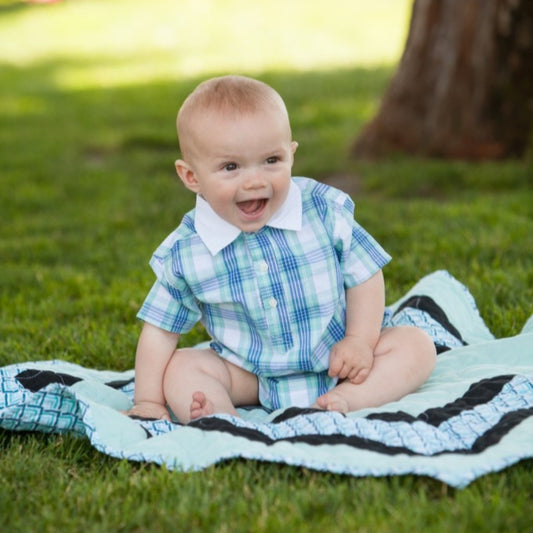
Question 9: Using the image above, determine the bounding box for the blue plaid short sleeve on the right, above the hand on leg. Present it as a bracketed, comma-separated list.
[333, 193, 391, 288]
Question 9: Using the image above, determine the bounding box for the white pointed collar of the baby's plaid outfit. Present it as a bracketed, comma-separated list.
[194, 181, 302, 255]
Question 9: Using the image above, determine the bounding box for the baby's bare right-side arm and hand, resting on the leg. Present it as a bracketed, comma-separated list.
[329, 270, 385, 384]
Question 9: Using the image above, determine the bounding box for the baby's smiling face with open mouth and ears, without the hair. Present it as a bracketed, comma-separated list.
[177, 109, 298, 232]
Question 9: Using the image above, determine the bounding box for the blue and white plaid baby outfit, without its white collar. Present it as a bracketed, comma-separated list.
[138, 178, 390, 409]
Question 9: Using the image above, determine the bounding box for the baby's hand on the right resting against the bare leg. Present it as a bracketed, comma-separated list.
[328, 336, 374, 385]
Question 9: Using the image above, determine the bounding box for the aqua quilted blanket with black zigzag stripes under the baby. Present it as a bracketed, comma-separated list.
[0, 271, 533, 487]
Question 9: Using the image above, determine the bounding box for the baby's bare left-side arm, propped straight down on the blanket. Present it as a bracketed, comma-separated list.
[126, 323, 179, 420]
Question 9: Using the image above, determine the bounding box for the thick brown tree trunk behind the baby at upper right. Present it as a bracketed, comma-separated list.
[353, 0, 533, 159]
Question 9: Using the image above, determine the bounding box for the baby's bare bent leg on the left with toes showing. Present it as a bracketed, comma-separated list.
[163, 348, 258, 423]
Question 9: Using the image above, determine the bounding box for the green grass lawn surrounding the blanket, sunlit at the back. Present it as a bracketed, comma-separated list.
[0, 0, 533, 533]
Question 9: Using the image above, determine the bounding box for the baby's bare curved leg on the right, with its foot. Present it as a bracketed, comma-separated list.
[317, 326, 436, 412]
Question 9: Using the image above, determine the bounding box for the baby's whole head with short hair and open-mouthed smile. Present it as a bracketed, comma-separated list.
[176, 76, 298, 231]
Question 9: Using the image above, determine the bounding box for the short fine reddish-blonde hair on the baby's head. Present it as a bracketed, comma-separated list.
[176, 75, 290, 158]
